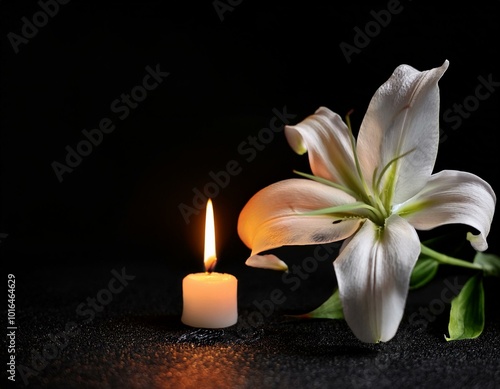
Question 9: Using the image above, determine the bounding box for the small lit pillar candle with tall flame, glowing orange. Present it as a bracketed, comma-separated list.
[181, 199, 238, 328]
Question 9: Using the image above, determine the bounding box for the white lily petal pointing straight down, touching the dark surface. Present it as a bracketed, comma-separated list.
[333, 215, 420, 343]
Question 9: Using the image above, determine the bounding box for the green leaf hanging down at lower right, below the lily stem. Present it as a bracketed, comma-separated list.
[445, 274, 484, 341]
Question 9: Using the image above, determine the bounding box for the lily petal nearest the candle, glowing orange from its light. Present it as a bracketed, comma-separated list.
[238, 178, 362, 255]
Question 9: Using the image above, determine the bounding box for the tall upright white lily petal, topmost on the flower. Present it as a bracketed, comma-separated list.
[357, 60, 448, 203]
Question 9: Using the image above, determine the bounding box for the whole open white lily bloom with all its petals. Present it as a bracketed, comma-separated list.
[238, 61, 496, 343]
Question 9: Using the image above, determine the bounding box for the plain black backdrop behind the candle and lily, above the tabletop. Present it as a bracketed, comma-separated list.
[0, 0, 500, 384]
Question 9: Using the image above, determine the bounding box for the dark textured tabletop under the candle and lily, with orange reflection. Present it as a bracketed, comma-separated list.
[4, 253, 500, 389]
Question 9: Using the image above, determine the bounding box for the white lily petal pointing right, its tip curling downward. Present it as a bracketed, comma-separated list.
[395, 170, 496, 251]
